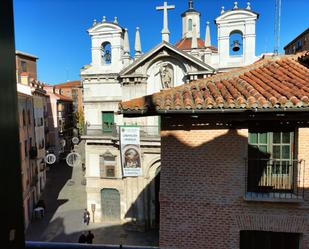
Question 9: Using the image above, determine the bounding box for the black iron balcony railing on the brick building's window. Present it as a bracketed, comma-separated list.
[245, 159, 305, 201]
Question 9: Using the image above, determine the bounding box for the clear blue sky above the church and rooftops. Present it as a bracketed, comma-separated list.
[14, 0, 309, 84]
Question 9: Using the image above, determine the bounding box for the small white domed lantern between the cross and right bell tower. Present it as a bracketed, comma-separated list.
[181, 0, 201, 38]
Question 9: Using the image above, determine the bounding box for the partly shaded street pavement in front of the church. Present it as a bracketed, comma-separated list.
[26, 145, 158, 246]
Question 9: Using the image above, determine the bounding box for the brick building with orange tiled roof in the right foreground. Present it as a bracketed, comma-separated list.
[120, 52, 309, 249]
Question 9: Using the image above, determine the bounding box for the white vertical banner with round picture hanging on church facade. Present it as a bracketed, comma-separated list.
[120, 126, 142, 176]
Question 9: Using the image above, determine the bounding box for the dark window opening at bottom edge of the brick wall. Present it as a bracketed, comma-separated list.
[240, 231, 299, 249]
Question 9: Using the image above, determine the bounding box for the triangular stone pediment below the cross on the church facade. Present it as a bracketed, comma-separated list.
[120, 42, 215, 77]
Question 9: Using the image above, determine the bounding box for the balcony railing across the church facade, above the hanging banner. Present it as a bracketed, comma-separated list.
[83, 125, 160, 138]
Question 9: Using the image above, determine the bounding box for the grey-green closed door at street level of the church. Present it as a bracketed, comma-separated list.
[101, 188, 120, 221]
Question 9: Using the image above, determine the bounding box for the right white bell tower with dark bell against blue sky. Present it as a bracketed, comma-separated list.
[215, 2, 259, 68]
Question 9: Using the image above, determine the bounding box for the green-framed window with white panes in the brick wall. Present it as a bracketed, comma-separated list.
[248, 131, 297, 192]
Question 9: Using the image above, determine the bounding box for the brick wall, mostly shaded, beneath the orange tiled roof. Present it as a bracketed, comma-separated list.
[160, 119, 309, 249]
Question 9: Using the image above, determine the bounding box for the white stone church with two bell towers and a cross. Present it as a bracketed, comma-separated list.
[81, 0, 258, 228]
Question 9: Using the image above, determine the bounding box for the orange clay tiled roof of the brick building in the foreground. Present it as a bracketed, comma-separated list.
[119, 51, 309, 114]
